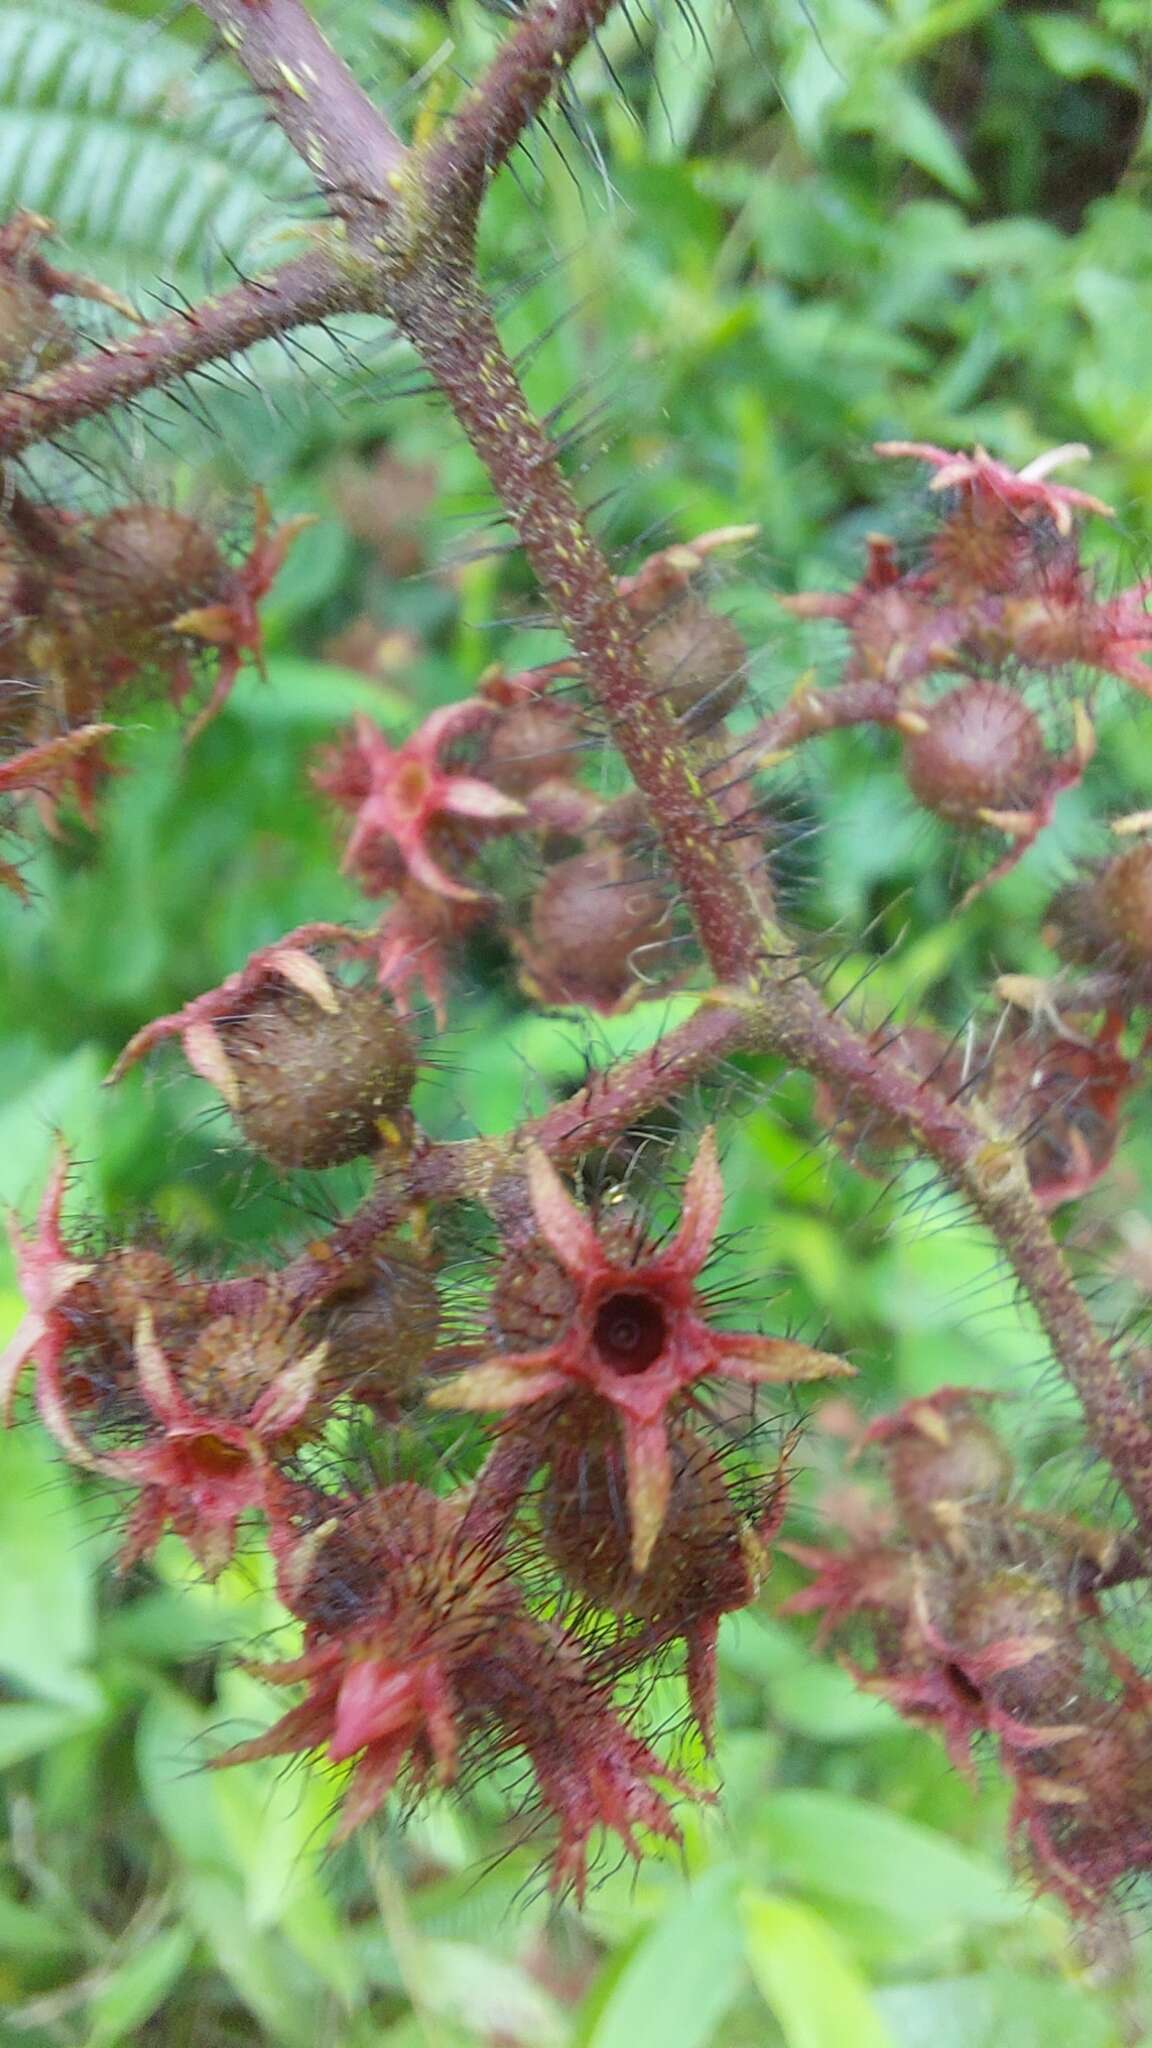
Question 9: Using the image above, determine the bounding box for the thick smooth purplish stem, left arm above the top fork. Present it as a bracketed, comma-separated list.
[197, 0, 406, 219]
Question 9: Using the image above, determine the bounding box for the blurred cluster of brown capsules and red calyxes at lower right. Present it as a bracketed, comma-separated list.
[785, 1386, 1152, 1917]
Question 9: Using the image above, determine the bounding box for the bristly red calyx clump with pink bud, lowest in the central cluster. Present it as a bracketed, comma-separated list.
[217, 1483, 678, 1896]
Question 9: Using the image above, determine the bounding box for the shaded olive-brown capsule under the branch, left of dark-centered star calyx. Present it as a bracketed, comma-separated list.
[305, 1245, 441, 1415]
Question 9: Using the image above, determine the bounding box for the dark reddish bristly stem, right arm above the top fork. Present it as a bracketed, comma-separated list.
[422, 0, 615, 221]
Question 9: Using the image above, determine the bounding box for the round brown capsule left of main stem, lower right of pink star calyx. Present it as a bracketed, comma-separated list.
[519, 846, 668, 1012]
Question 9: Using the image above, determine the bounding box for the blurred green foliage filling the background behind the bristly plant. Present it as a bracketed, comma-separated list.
[0, 0, 1152, 2048]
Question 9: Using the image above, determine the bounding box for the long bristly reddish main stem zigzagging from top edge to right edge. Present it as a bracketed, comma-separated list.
[192, 0, 1152, 1530]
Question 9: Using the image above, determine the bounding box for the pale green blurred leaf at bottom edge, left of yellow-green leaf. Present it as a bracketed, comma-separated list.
[574, 1864, 744, 2048]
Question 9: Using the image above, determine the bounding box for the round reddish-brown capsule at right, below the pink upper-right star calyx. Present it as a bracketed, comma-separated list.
[904, 682, 1050, 825]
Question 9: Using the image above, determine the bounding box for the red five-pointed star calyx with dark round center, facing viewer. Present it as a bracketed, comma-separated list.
[430, 1130, 851, 1571]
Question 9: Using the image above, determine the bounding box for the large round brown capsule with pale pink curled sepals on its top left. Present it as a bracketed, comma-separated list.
[217, 983, 416, 1167]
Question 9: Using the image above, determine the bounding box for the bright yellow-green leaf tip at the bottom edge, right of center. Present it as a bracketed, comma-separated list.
[740, 1892, 896, 2048]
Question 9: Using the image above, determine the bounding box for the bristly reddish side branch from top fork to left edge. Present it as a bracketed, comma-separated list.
[0, 250, 361, 457]
